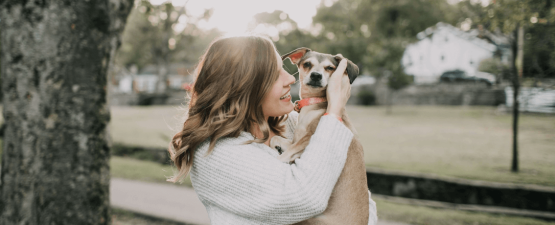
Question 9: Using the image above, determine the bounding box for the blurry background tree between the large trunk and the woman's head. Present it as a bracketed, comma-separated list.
[116, 0, 215, 93]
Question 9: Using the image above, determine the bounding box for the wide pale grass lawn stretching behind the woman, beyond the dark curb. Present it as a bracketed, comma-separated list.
[110, 106, 555, 186]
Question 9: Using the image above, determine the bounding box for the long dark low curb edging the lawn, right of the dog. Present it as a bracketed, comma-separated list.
[366, 168, 555, 213]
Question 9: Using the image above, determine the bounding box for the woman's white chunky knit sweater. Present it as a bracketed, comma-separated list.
[191, 111, 377, 225]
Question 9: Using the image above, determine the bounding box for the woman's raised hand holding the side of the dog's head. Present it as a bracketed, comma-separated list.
[326, 59, 351, 117]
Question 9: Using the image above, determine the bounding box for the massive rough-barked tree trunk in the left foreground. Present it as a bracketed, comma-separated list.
[0, 0, 133, 225]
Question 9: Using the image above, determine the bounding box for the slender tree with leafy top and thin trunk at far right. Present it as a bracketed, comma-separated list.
[459, 0, 555, 172]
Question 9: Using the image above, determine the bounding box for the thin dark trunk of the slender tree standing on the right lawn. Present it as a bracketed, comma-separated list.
[511, 25, 524, 173]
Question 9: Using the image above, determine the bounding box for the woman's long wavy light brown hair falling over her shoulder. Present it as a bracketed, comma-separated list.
[168, 36, 287, 182]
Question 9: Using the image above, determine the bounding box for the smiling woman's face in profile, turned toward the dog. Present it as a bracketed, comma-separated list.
[262, 51, 295, 117]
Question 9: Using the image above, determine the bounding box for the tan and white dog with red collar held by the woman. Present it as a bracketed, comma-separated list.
[270, 47, 369, 225]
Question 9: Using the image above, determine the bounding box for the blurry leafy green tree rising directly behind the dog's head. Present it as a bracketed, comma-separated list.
[314, 0, 456, 76]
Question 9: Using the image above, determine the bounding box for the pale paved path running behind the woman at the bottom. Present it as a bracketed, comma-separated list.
[110, 178, 406, 225]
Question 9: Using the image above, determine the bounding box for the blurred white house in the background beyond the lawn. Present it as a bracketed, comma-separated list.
[401, 22, 512, 83]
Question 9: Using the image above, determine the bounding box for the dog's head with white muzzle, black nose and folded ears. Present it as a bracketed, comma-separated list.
[281, 47, 358, 98]
